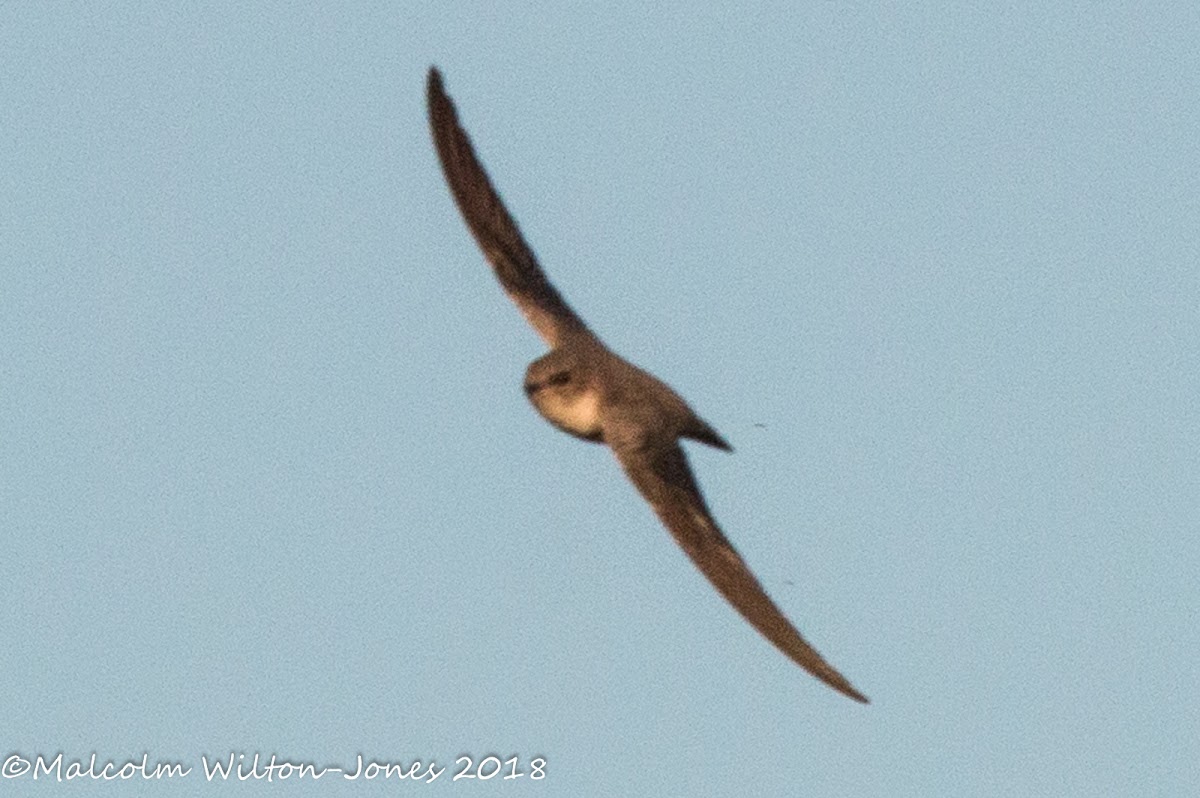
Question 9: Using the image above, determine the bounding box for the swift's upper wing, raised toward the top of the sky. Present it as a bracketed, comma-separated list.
[427, 68, 587, 347]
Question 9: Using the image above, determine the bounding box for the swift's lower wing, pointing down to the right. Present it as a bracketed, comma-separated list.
[605, 425, 869, 703]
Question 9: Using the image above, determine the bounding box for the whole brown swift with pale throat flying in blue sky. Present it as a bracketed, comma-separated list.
[426, 67, 868, 703]
